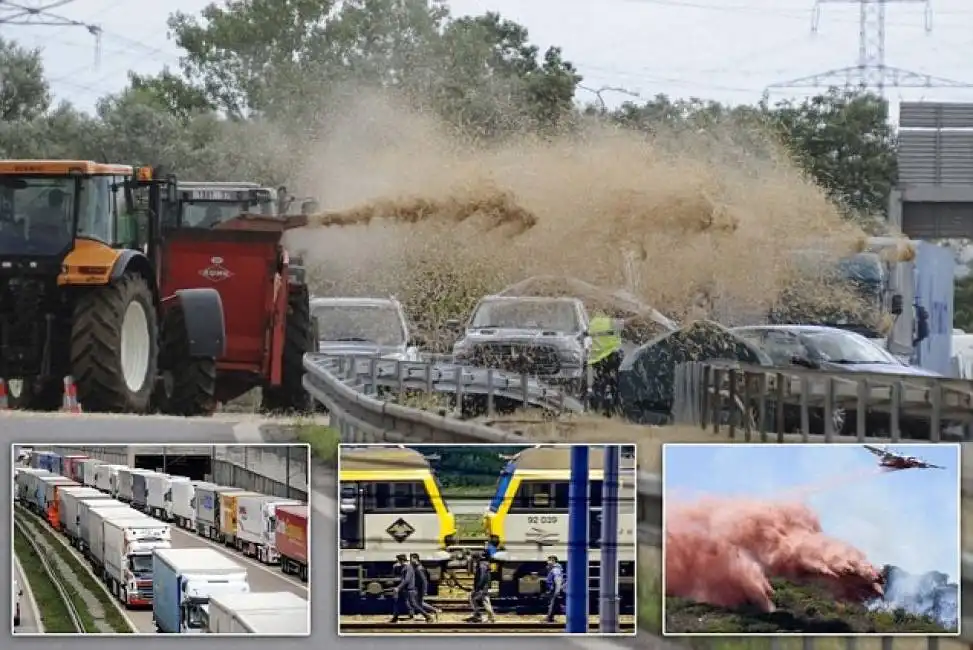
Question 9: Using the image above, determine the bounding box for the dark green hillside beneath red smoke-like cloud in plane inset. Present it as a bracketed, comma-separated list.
[665, 580, 949, 634]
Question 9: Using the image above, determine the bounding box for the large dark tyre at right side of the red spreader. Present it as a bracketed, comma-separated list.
[261, 285, 317, 413]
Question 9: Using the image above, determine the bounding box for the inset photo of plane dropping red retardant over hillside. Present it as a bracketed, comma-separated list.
[662, 443, 962, 637]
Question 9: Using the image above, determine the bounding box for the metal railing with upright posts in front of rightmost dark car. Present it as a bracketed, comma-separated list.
[672, 360, 973, 442]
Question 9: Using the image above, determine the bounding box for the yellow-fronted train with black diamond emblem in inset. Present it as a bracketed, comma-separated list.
[338, 446, 458, 614]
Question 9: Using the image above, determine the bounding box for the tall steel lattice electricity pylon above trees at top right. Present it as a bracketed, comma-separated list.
[769, 0, 973, 97]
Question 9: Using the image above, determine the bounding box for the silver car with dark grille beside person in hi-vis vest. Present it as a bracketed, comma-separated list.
[453, 296, 591, 393]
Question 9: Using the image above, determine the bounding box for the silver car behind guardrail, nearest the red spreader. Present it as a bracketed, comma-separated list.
[311, 298, 419, 361]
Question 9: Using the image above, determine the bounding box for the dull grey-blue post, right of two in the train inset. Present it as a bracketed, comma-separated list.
[598, 445, 622, 634]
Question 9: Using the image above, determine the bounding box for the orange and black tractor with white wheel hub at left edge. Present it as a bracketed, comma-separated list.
[0, 160, 225, 415]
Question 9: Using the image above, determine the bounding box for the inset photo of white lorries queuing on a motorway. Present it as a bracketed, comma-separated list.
[11, 443, 313, 638]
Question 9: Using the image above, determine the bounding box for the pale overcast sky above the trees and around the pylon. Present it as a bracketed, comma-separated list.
[0, 0, 973, 117]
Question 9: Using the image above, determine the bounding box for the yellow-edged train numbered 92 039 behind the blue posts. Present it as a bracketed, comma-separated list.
[483, 446, 636, 614]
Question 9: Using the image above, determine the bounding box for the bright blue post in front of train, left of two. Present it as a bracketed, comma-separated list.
[566, 445, 588, 634]
